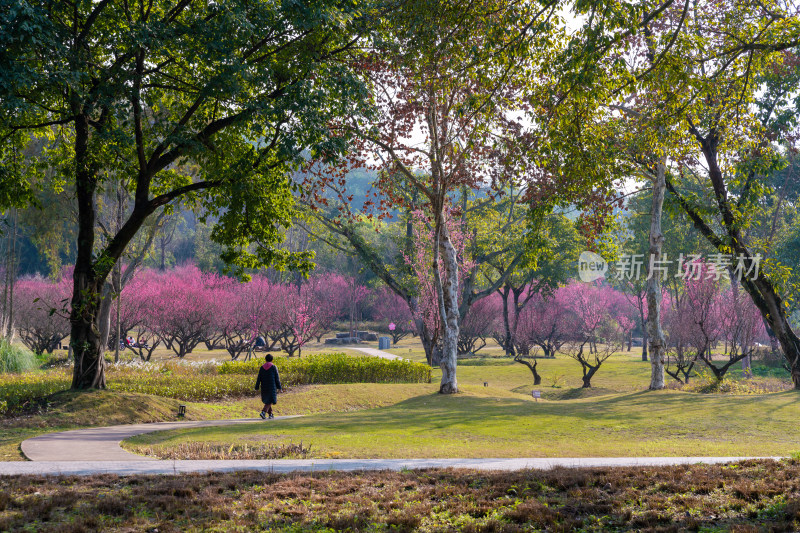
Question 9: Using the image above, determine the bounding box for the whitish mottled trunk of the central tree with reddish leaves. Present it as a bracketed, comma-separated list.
[433, 220, 460, 394]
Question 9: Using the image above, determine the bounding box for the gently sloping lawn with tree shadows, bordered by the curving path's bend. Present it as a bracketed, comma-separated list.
[125, 387, 800, 458]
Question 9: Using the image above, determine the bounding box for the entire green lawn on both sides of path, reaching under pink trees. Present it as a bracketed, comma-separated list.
[0, 339, 800, 460]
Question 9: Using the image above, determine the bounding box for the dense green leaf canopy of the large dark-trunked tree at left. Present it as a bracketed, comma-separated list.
[0, 0, 379, 286]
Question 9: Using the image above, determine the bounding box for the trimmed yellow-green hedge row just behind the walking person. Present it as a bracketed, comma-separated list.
[219, 353, 431, 385]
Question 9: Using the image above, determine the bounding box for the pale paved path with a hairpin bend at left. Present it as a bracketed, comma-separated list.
[0, 416, 779, 475]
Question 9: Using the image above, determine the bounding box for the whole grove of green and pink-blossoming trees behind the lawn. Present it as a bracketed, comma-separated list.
[0, 0, 800, 394]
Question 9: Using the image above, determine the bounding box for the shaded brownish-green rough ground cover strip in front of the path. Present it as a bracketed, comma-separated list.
[0, 461, 800, 533]
